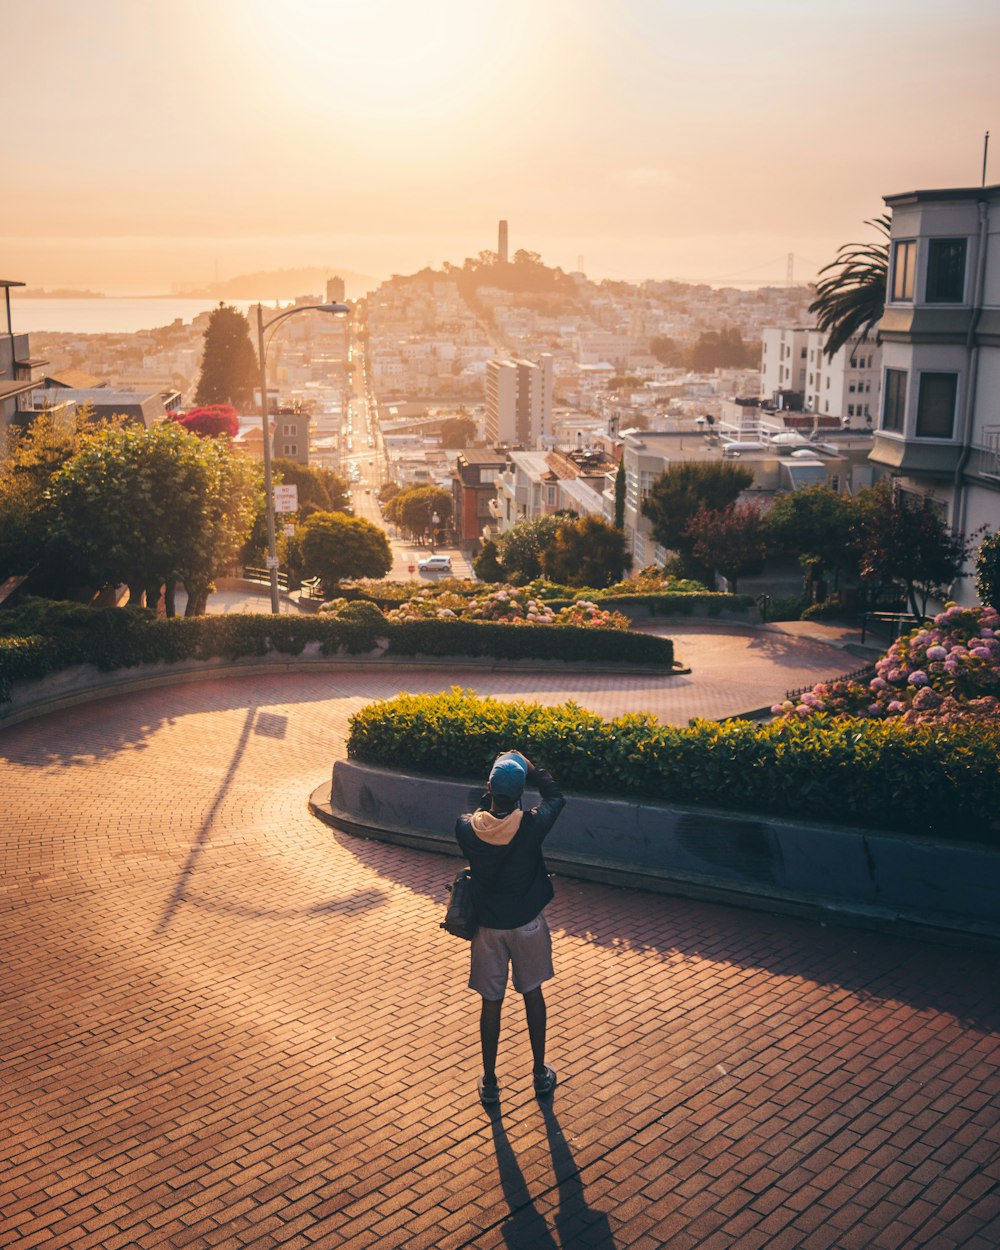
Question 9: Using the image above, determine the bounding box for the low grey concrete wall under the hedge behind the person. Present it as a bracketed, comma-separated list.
[309, 760, 1000, 946]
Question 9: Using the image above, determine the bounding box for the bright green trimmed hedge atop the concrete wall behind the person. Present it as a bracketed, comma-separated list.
[348, 689, 1000, 846]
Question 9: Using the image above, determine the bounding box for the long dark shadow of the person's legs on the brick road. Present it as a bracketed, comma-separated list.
[490, 1101, 615, 1250]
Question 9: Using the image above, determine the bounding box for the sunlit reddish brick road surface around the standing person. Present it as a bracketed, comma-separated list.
[0, 655, 1000, 1250]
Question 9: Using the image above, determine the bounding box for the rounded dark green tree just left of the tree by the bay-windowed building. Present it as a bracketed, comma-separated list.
[764, 483, 858, 600]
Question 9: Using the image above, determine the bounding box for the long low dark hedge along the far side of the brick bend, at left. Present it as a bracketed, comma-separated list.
[0, 604, 674, 703]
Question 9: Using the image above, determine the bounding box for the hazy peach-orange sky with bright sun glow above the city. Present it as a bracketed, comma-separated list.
[0, 0, 1000, 291]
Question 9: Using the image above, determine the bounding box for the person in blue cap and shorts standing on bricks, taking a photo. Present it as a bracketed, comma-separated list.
[455, 751, 566, 1105]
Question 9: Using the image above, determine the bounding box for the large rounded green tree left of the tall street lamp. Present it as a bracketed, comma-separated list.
[49, 421, 260, 615]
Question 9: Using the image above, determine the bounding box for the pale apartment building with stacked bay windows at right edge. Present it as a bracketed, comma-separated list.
[871, 185, 1000, 604]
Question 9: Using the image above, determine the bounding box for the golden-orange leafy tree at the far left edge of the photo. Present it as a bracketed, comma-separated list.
[0, 414, 78, 595]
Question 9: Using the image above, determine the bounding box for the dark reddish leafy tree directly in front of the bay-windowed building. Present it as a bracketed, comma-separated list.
[854, 481, 969, 619]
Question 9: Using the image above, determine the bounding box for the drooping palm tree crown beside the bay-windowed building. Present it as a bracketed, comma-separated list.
[809, 214, 893, 356]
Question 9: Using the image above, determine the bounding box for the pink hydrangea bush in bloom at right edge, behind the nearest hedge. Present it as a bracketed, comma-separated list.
[771, 604, 1000, 725]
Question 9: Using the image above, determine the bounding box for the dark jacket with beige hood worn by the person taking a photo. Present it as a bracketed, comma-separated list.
[455, 769, 566, 929]
